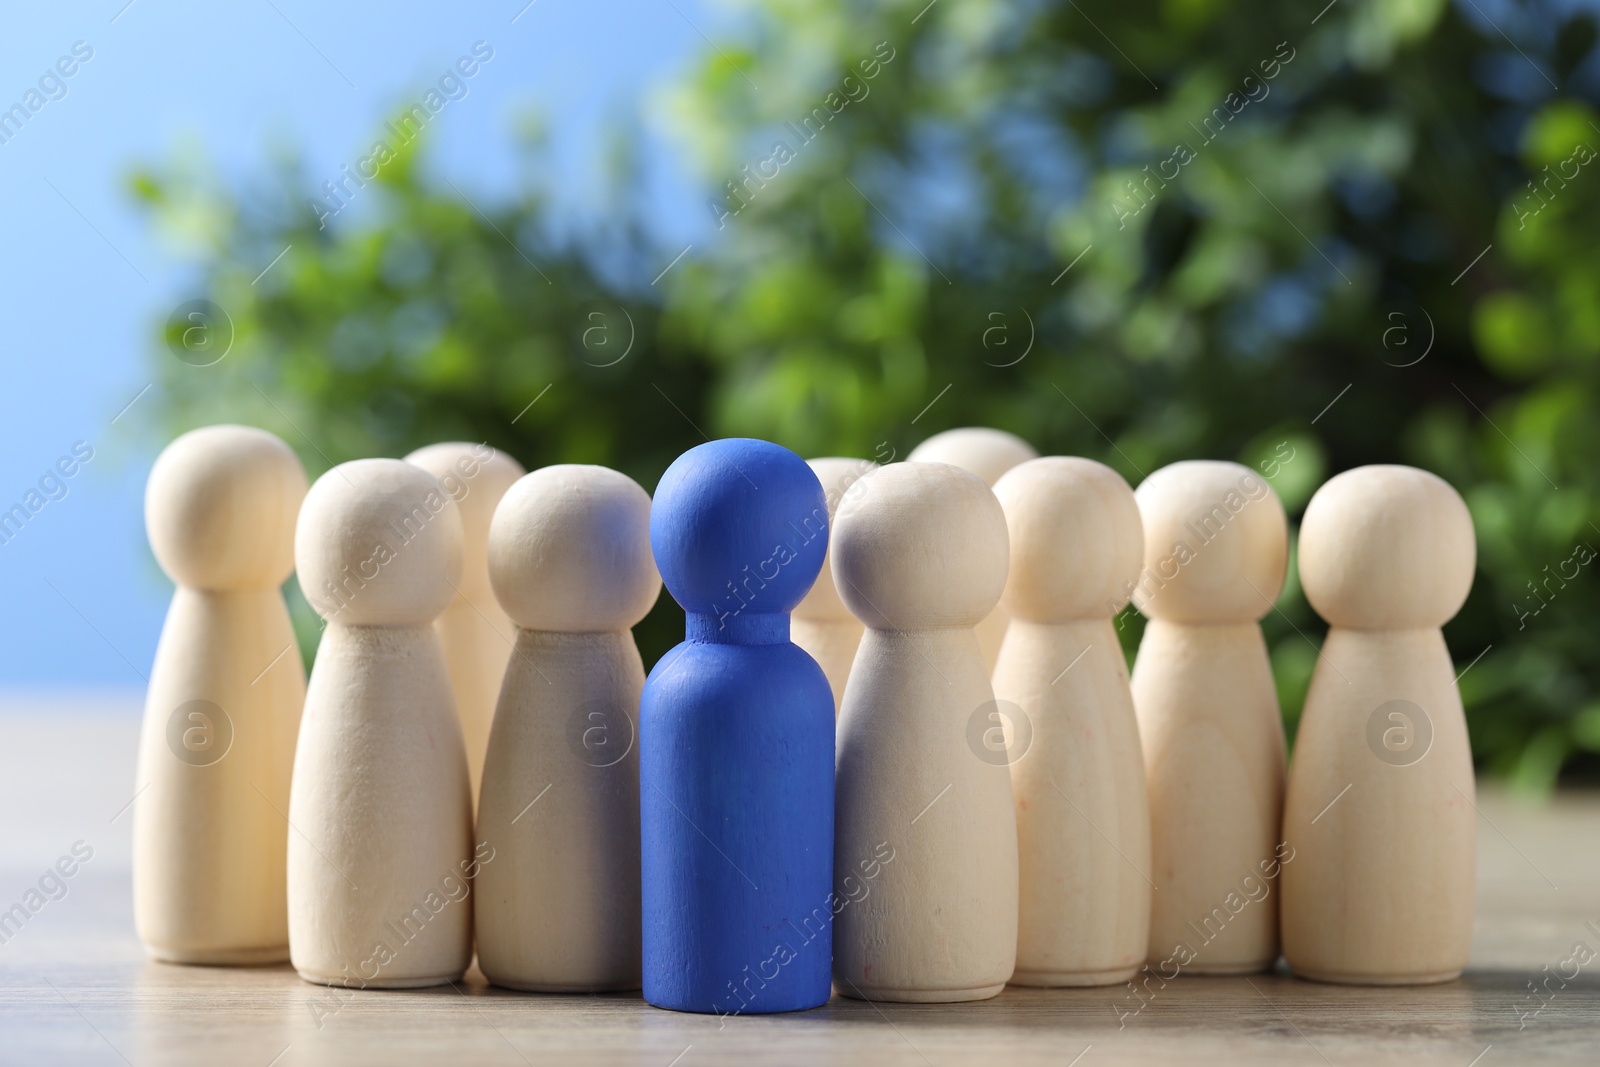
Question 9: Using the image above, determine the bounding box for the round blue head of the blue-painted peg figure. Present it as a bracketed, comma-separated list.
[650, 437, 827, 619]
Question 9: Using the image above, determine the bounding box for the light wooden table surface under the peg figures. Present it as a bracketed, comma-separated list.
[0, 697, 1600, 1067]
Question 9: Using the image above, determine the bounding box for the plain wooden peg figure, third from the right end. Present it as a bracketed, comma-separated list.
[994, 458, 1152, 985]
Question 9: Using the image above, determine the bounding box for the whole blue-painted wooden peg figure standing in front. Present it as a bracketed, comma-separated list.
[638, 440, 834, 1014]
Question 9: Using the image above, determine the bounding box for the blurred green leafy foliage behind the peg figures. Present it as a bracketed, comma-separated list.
[134, 0, 1600, 792]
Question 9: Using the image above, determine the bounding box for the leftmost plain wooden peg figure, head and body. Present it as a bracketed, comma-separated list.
[133, 426, 306, 965]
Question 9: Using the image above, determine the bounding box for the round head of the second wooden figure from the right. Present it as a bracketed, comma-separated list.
[1133, 459, 1290, 622]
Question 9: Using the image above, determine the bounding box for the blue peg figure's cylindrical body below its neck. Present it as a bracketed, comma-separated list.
[638, 639, 834, 1016]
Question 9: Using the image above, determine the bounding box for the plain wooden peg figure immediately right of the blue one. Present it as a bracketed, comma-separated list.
[832, 462, 1018, 1001]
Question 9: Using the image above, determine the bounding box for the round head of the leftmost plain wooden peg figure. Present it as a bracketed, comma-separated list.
[144, 426, 306, 590]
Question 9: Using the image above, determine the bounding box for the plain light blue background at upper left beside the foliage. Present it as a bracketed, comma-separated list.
[0, 0, 731, 691]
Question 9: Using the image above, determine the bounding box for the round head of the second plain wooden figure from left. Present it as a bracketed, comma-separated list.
[294, 459, 462, 625]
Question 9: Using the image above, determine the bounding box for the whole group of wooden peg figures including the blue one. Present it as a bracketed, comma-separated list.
[134, 426, 1475, 1014]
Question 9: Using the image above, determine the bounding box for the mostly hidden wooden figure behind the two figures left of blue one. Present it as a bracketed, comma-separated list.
[405, 442, 523, 803]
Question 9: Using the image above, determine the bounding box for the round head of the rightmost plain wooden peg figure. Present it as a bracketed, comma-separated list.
[1299, 466, 1477, 630]
